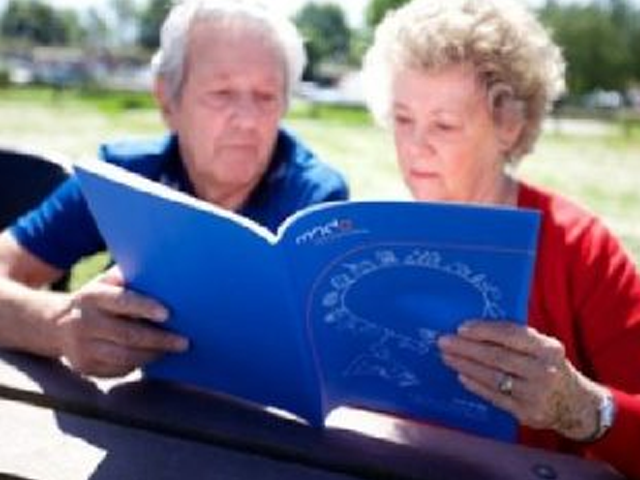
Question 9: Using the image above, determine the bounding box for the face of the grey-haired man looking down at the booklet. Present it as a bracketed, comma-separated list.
[164, 22, 286, 207]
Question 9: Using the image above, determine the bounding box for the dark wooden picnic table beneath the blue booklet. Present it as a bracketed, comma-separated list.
[0, 351, 622, 480]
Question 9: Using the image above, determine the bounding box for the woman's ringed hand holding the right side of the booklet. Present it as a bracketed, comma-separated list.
[438, 320, 607, 440]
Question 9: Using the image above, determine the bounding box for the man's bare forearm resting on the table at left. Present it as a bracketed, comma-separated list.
[0, 276, 70, 357]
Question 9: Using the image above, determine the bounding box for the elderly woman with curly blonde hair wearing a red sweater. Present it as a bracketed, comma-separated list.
[364, 0, 640, 478]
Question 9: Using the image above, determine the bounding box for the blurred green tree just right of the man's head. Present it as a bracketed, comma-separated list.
[294, 2, 351, 78]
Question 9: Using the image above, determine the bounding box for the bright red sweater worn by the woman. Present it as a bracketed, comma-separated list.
[518, 184, 640, 479]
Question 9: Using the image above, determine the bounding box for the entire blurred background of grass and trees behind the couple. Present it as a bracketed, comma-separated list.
[0, 0, 640, 280]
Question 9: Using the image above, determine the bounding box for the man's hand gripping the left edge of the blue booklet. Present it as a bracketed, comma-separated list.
[57, 269, 188, 377]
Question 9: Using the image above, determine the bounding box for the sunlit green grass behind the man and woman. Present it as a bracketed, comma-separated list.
[0, 89, 640, 284]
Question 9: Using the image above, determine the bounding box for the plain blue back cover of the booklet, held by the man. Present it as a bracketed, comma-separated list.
[76, 162, 322, 424]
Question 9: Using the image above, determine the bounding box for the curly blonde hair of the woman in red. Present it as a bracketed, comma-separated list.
[363, 0, 565, 162]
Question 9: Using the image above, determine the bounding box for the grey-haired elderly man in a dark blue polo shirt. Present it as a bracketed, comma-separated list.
[0, 0, 347, 376]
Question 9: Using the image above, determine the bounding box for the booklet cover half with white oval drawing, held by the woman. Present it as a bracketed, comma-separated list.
[283, 202, 539, 439]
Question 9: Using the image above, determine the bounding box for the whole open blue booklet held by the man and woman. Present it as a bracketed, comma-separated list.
[76, 162, 539, 440]
